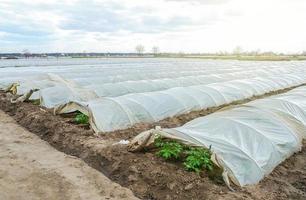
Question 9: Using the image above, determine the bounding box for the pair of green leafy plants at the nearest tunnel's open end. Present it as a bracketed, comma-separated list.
[154, 136, 214, 173]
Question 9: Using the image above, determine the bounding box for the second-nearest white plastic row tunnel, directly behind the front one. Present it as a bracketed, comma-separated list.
[57, 73, 306, 132]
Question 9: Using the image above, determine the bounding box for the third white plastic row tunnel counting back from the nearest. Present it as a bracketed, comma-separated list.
[37, 69, 304, 108]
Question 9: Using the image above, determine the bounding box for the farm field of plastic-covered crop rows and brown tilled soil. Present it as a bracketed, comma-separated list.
[0, 58, 306, 199]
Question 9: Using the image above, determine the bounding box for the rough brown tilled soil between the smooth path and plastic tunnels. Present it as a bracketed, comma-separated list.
[0, 88, 306, 200]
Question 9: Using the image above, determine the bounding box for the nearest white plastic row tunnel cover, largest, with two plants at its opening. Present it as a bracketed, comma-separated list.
[132, 87, 306, 186]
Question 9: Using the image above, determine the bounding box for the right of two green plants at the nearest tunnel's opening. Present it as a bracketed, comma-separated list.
[184, 148, 213, 173]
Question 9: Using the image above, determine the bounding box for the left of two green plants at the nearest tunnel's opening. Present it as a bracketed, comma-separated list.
[155, 137, 184, 160]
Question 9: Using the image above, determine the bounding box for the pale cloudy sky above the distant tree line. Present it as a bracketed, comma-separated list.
[0, 0, 306, 53]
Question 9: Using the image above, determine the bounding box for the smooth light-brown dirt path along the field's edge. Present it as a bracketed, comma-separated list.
[0, 111, 136, 200]
